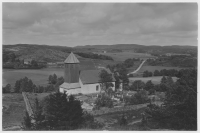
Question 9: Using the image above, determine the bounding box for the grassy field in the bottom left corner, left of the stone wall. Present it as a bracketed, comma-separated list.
[2, 93, 26, 129]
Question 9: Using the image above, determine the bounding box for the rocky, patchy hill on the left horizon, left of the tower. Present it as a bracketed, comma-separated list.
[3, 44, 72, 62]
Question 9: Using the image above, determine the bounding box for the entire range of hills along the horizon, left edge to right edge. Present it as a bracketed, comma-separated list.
[3, 44, 197, 62]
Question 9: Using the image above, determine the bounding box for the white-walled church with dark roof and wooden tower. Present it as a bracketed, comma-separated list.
[59, 53, 115, 95]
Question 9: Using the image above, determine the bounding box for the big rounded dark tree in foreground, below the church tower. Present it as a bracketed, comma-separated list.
[44, 92, 83, 130]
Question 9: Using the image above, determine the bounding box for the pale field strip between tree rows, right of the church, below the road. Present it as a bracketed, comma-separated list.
[129, 76, 177, 85]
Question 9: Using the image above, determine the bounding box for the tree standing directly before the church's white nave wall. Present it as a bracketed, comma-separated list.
[99, 69, 114, 93]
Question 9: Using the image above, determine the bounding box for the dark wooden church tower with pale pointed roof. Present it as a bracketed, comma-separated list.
[64, 52, 80, 83]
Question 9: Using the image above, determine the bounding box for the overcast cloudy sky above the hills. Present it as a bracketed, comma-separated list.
[3, 3, 198, 46]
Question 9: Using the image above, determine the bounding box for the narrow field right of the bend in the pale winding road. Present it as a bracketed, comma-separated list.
[137, 65, 183, 73]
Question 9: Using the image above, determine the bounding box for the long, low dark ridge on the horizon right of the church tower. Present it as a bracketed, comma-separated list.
[74, 44, 197, 56]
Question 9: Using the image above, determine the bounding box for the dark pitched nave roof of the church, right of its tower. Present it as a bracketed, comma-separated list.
[80, 69, 115, 84]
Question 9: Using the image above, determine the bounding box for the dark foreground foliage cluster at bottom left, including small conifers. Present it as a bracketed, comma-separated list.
[22, 92, 103, 130]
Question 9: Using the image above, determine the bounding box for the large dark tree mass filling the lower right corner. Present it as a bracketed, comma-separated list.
[146, 69, 197, 130]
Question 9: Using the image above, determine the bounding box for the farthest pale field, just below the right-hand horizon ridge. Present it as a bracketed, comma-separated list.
[101, 52, 154, 61]
